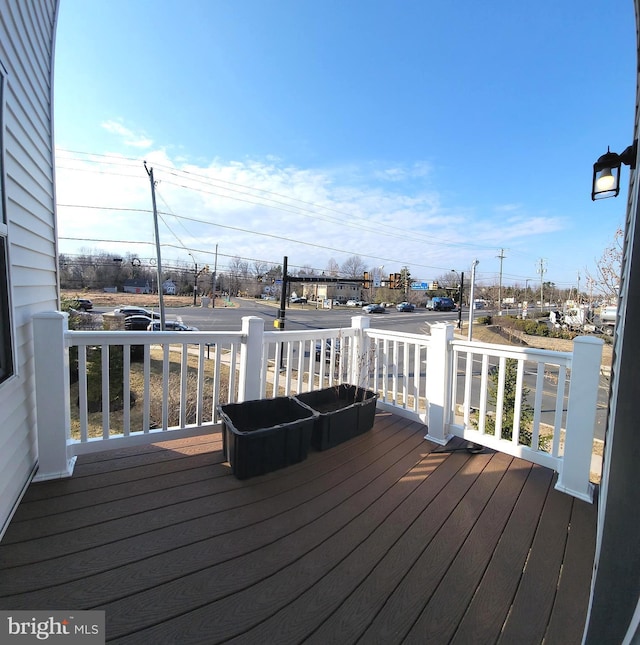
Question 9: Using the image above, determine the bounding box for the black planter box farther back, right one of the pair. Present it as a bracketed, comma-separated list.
[295, 384, 378, 450]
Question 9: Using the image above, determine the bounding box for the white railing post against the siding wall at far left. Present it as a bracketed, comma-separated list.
[33, 311, 76, 481]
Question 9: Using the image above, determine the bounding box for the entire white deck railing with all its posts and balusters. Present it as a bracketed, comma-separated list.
[34, 312, 602, 499]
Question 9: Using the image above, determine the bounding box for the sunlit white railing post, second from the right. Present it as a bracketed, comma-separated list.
[424, 323, 453, 446]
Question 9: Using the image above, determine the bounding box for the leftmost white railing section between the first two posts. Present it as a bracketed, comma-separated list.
[65, 331, 242, 444]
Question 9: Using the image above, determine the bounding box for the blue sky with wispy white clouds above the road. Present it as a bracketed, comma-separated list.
[55, 0, 636, 289]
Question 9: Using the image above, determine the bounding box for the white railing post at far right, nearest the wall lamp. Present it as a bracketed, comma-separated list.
[555, 336, 604, 502]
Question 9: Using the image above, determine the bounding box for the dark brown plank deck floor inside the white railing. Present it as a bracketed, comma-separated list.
[0, 412, 596, 645]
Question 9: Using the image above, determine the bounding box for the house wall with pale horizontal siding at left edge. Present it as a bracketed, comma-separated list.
[0, 0, 58, 535]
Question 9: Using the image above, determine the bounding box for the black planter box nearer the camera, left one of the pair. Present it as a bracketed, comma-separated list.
[218, 397, 317, 479]
